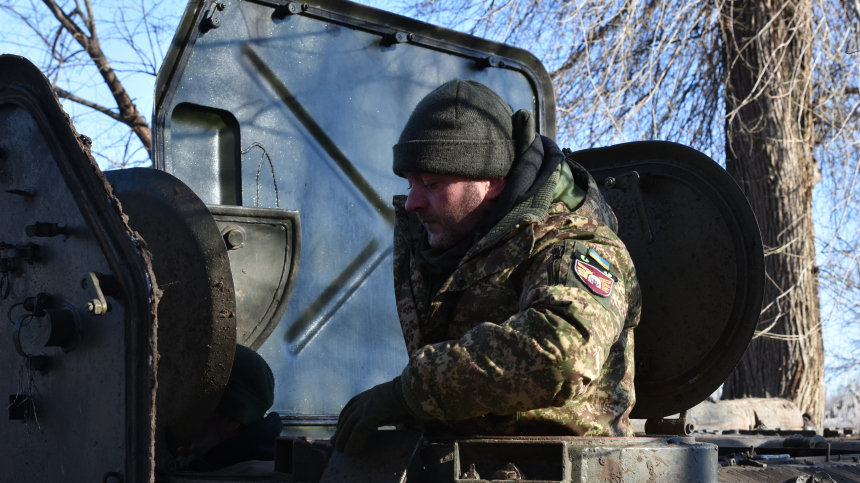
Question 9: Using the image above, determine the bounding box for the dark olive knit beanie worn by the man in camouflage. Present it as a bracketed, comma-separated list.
[393, 79, 535, 178]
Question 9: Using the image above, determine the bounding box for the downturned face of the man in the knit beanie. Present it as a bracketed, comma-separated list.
[403, 173, 505, 248]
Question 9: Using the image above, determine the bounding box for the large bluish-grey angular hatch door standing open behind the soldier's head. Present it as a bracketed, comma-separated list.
[153, 0, 555, 428]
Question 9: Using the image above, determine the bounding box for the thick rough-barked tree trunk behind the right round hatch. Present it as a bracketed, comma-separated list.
[721, 0, 824, 426]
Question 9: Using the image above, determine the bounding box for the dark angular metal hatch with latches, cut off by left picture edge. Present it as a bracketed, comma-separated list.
[0, 55, 158, 482]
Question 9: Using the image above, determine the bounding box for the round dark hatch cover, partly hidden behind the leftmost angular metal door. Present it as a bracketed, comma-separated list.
[105, 168, 236, 450]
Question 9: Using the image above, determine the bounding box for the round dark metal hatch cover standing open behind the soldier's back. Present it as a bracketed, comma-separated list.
[571, 141, 765, 418]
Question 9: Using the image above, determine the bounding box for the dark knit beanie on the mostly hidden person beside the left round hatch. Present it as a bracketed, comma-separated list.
[215, 344, 275, 424]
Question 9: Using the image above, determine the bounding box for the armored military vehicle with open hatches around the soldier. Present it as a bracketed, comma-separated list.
[0, 0, 860, 483]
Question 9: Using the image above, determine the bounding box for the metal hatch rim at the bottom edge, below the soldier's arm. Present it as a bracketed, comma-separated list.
[306, 431, 718, 483]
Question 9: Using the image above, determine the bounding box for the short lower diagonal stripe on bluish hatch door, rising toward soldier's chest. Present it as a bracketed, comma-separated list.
[285, 239, 392, 354]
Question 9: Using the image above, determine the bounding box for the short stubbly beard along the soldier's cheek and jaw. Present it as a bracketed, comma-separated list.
[418, 182, 484, 248]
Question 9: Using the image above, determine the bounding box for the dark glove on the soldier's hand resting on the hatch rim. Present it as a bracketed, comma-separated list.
[331, 376, 415, 456]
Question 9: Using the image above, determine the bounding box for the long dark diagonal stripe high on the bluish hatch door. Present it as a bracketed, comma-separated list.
[242, 44, 394, 225]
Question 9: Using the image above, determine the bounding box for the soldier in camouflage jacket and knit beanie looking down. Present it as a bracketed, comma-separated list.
[331, 80, 641, 454]
